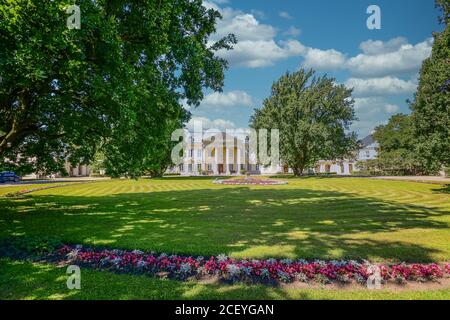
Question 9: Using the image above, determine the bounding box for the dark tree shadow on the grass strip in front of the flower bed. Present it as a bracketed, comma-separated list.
[0, 259, 296, 300]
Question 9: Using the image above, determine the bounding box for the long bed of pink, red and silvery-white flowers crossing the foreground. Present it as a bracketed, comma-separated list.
[51, 245, 450, 284]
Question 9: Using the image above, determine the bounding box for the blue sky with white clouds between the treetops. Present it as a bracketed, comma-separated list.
[187, 0, 442, 138]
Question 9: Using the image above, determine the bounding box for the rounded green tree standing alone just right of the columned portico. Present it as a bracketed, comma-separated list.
[250, 70, 356, 175]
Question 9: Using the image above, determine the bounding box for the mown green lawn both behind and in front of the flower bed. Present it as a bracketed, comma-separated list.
[0, 177, 450, 298]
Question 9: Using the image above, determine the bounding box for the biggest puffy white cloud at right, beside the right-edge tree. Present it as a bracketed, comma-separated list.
[347, 38, 433, 77]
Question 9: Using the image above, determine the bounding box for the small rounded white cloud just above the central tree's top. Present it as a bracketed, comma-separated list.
[302, 48, 345, 71]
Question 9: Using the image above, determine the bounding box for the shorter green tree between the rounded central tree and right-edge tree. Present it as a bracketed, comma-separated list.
[372, 114, 427, 175]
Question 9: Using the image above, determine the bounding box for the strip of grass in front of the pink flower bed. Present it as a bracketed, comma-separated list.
[0, 259, 450, 300]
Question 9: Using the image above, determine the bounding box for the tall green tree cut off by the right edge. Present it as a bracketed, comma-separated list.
[411, 0, 450, 172]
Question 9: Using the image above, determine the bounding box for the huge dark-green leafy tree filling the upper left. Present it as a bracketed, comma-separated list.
[0, 0, 235, 176]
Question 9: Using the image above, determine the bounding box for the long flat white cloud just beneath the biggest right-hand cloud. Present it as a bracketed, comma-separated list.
[345, 77, 417, 97]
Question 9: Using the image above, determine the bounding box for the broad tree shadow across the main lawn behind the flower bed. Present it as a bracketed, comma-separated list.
[0, 187, 450, 262]
